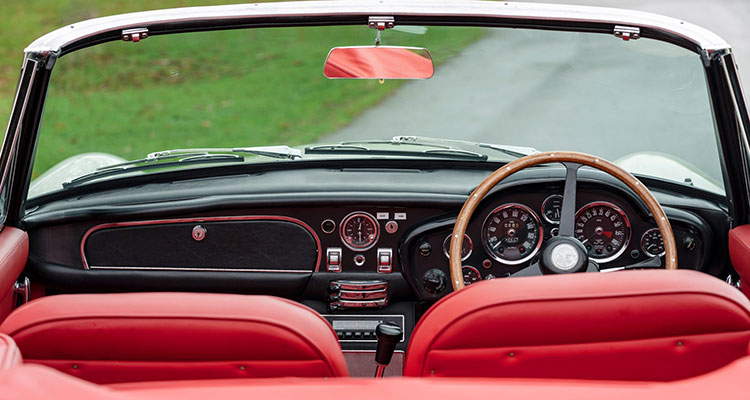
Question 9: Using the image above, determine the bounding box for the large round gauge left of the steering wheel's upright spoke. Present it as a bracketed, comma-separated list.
[482, 203, 543, 265]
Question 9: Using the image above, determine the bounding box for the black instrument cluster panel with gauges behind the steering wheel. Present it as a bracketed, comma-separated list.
[402, 186, 707, 299]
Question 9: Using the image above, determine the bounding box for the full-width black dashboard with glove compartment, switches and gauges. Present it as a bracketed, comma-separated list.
[24, 162, 728, 349]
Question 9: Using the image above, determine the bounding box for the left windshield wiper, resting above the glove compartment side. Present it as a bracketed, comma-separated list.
[62, 146, 302, 188]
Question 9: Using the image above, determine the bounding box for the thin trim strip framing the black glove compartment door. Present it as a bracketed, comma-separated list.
[81, 215, 322, 274]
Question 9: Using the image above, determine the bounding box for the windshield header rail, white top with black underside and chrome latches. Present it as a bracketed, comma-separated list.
[24, 0, 730, 62]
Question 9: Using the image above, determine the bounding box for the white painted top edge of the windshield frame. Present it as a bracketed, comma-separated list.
[24, 0, 730, 53]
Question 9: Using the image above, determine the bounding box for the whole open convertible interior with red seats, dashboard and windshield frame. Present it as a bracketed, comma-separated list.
[0, 0, 750, 399]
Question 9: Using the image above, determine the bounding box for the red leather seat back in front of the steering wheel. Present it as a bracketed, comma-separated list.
[404, 270, 750, 381]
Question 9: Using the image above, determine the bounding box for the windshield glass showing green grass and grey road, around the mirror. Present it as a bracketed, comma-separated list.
[29, 26, 724, 197]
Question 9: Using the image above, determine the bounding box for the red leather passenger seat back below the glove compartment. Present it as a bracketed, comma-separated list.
[0, 293, 348, 383]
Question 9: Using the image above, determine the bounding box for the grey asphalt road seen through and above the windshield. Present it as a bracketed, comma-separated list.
[324, 0, 750, 188]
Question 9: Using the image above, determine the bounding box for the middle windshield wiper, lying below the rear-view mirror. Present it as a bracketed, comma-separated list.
[305, 141, 489, 161]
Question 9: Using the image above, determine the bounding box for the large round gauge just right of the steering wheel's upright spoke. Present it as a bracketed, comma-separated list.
[575, 201, 630, 263]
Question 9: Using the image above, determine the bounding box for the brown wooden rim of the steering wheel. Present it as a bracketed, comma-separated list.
[450, 151, 677, 290]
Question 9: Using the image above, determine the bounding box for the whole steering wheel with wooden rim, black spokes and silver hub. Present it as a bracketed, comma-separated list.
[450, 151, 677, 290]
